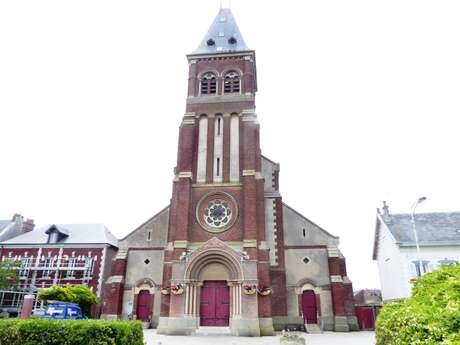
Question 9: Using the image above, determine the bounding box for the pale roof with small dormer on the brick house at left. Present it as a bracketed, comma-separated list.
[2, 224, 118, 247]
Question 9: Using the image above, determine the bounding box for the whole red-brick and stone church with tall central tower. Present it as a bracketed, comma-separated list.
[101, 8, 358, 336]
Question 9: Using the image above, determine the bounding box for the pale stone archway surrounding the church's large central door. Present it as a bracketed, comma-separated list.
[158, 237, 260, 336]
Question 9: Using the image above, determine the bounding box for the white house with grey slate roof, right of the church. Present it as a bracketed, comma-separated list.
[373, 202, 460, 302]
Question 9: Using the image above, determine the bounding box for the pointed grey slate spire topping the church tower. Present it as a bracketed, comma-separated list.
[193, 8, 249, 54]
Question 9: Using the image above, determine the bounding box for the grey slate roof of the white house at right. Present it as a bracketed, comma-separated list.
[381, 212, 460, 246]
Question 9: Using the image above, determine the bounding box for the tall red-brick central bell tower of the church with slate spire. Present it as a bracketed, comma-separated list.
[159, 9, 273, 336]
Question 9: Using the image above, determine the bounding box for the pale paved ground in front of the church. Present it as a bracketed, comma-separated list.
[144, 329, 375, 345]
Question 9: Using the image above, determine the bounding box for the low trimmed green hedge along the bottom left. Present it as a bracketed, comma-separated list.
[0, 319, 144, 345]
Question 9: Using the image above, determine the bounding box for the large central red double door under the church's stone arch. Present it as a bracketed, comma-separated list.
[200, 281, 230, 326]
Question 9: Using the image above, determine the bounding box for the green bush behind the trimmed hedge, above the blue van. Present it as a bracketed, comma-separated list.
[38, 284, 99, 316]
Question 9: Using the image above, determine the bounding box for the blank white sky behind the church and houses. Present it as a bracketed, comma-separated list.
[0, 0, 460, 289]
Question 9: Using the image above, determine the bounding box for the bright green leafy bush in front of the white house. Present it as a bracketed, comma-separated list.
[376, 264, 460, 345]
